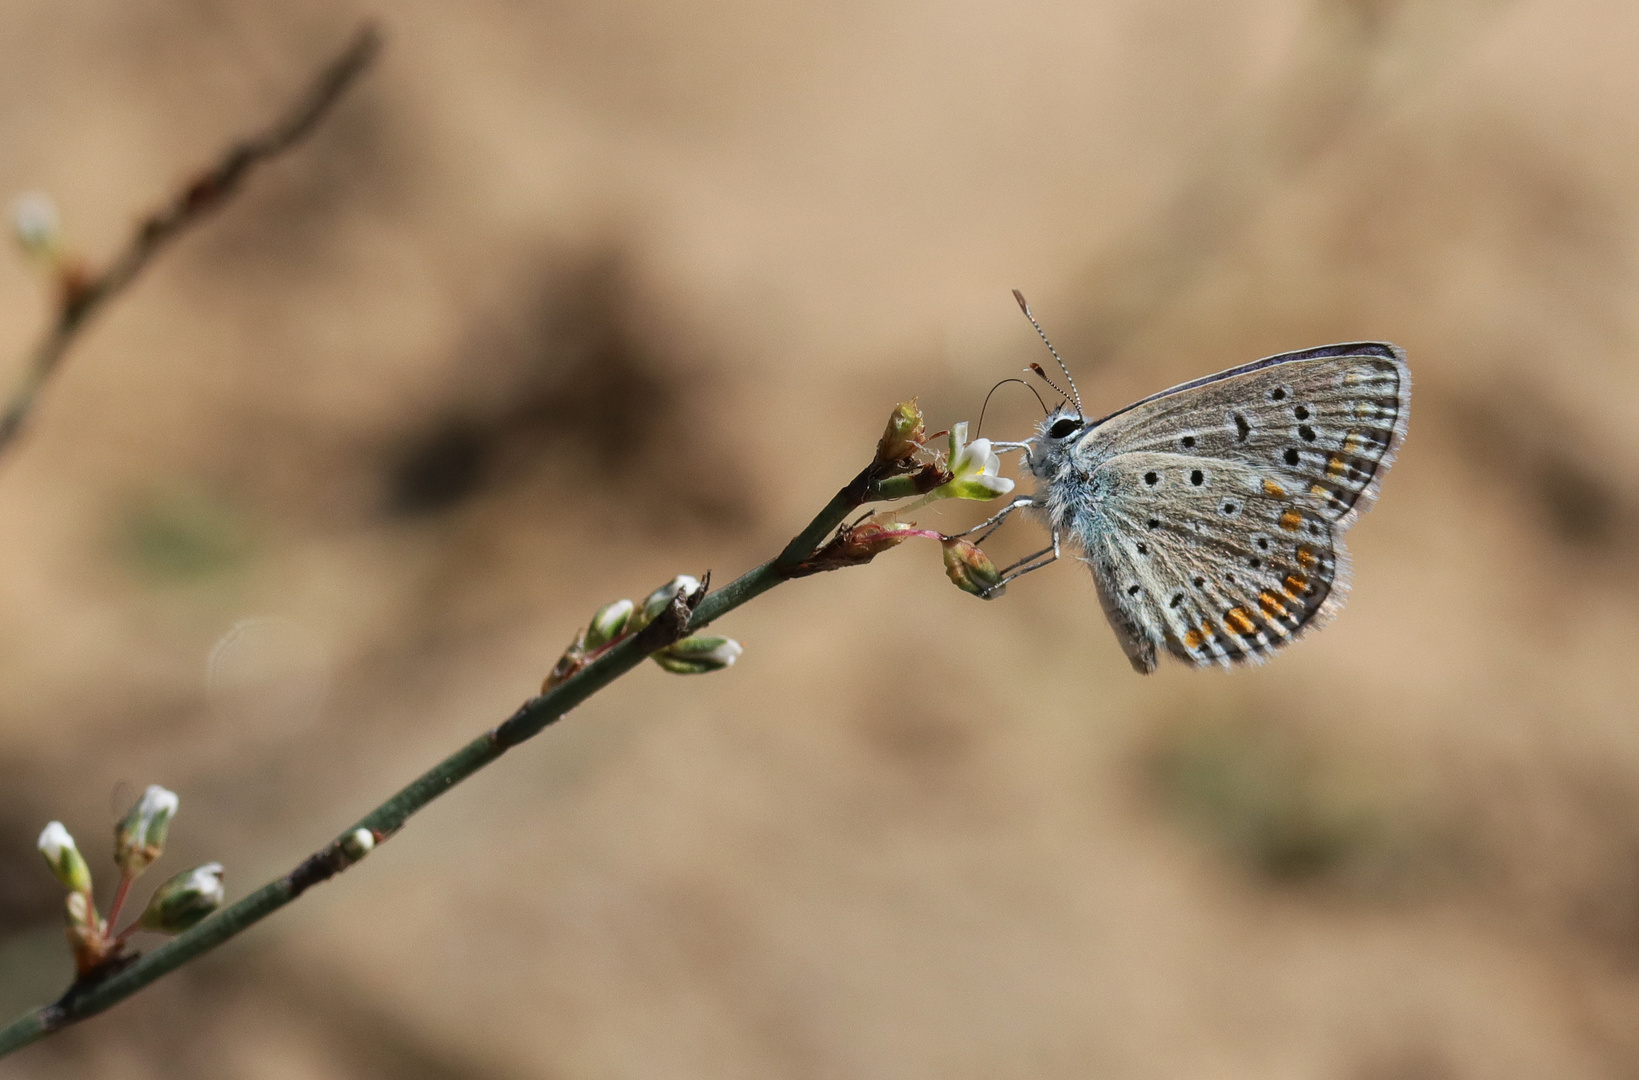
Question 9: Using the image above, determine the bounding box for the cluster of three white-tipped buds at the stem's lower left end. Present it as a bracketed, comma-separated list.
[39, 783, 223, 975]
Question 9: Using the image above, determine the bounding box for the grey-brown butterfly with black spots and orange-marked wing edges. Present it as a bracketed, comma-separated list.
[980, 298, 1411, 674]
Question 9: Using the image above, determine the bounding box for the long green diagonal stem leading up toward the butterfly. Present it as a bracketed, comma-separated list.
[0, 465, 882, 1057]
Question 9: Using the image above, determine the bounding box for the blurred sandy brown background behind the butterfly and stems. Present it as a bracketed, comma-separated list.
[0, 0, 1639, 1080]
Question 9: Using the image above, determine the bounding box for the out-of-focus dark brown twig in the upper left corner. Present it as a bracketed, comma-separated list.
[0, 23, 382, 454]
